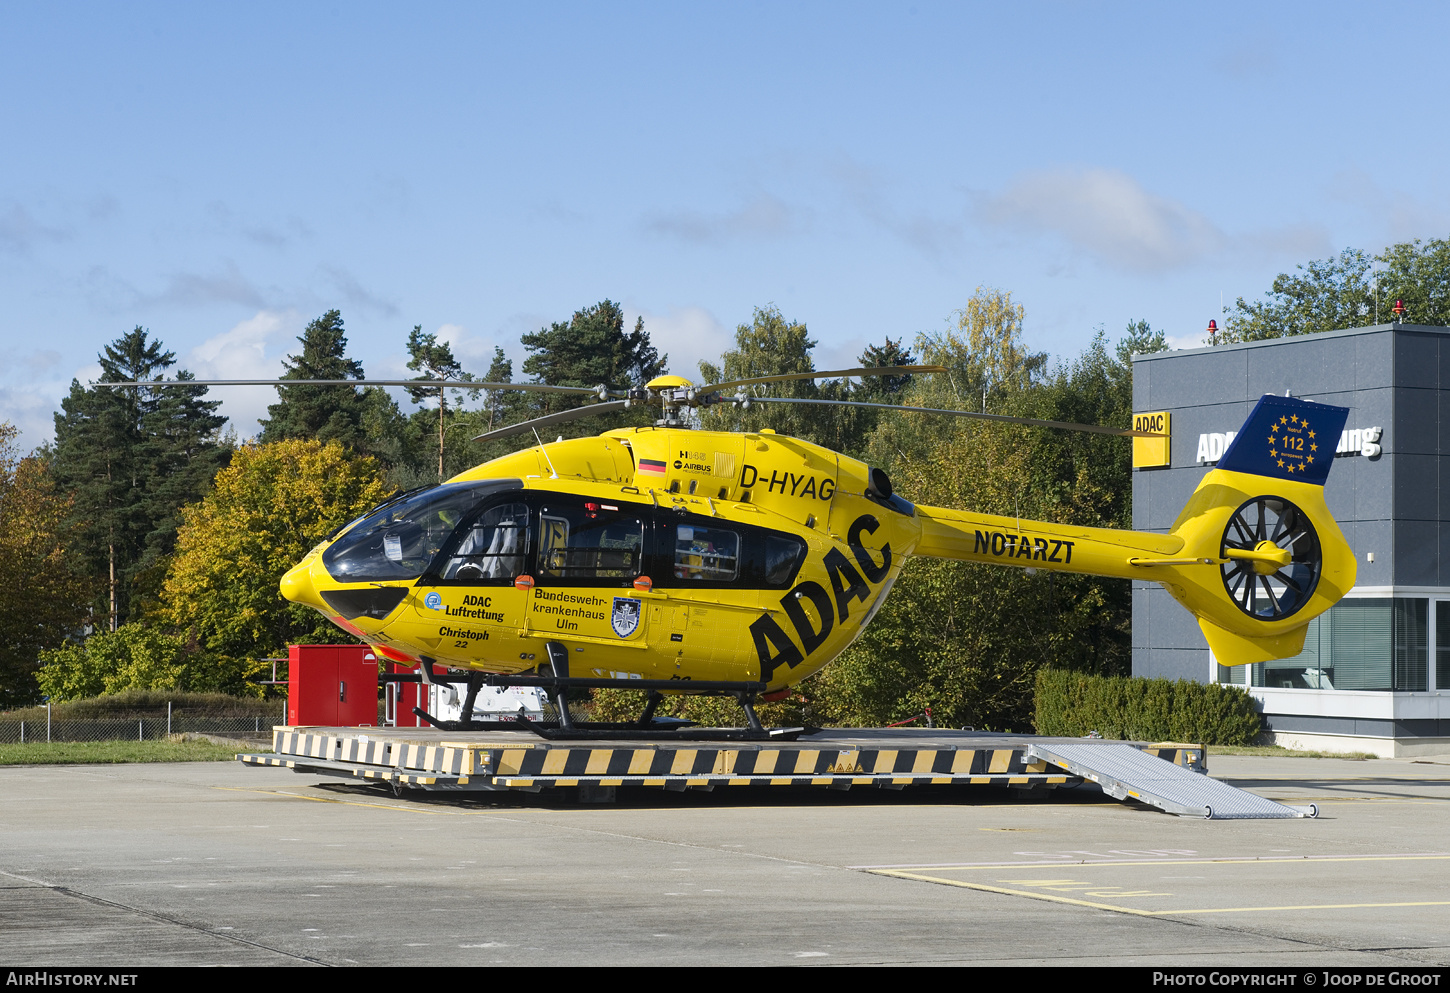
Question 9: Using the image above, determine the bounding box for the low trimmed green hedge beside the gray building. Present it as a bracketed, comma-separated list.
[1037, 670, 1260, 745]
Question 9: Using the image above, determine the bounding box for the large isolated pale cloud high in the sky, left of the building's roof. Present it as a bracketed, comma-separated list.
[977, 170, 1225, 271]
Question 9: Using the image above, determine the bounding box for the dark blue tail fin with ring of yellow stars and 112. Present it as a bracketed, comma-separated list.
[1218, 393, 1350, 486]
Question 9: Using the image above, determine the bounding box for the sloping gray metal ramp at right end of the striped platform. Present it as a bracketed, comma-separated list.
[1027, 742, 1320, 820]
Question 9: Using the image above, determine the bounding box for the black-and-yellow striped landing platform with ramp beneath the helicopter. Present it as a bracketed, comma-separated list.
[238, 728, 1305, 818]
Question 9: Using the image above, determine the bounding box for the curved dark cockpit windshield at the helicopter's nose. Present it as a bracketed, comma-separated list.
[322, 480, 518, 583]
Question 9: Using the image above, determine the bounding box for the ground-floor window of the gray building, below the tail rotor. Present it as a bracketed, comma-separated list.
[1241, 597, 1432, 693]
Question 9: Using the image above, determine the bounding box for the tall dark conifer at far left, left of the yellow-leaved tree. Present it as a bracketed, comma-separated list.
[52, 328, 229, 631]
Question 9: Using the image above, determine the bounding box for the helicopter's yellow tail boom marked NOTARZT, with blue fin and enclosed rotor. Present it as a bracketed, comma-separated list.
[915, 396, 1356, 665]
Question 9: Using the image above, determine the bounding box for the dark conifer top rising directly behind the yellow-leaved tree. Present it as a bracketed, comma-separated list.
[260, 310, 370, 451]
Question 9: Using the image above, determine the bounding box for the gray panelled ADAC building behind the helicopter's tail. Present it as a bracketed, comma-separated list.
[1132, 325, 1450, 757]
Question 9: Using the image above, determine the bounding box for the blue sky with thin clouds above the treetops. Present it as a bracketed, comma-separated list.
[0, 3, 1450, 446]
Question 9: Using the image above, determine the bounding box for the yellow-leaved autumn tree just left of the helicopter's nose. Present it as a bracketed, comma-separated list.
[162, 439, 390, 660]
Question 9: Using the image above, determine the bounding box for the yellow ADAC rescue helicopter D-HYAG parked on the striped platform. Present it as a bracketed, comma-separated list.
[255, 365, 1356, 736]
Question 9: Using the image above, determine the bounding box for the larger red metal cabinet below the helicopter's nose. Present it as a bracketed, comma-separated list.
[287, 645, 377, 728]
